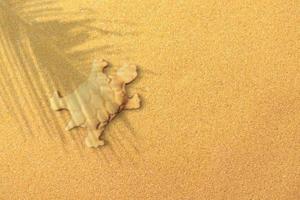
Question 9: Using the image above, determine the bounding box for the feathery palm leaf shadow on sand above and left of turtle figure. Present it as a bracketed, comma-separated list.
[0, 0, 140, 159]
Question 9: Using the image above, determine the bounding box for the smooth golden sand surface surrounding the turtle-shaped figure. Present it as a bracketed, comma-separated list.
[0, 0, 300, 200]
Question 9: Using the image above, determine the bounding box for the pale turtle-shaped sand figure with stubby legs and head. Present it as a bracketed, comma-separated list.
[50, 60, 141, 148]
